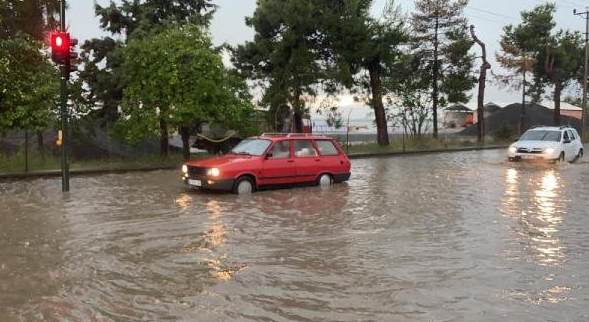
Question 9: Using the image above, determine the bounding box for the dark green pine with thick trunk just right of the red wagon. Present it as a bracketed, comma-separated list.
[323, 0, 408, 146]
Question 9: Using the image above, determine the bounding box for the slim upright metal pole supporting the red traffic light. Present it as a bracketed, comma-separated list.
[60, 0, 70, 192]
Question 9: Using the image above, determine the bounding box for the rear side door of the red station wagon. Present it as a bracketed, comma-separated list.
[293, 139, 321, 182]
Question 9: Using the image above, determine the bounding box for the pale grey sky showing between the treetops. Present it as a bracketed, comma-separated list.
[66, 0, 589, 118]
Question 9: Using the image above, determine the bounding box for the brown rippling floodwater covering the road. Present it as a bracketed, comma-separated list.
[0, 150, 589, 322]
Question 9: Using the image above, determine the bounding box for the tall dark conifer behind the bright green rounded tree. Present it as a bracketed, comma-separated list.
[79, 0, 215, 123]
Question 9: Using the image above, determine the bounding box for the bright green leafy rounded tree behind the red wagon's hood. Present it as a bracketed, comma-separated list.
[117, 24, 253, 158]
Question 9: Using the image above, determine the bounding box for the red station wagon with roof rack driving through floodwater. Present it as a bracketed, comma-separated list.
[182, 134, 350, 194]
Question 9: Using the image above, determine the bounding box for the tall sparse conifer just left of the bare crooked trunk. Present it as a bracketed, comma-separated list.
[412, 0, 474, 137]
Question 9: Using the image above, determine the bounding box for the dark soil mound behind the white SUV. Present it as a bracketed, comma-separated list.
[459, 103, 581, 135]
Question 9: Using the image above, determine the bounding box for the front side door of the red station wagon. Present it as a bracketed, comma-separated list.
[258, 140, 296, 185]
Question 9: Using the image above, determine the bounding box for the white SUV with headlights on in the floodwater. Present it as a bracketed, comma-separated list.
[507, 126, 583, 161]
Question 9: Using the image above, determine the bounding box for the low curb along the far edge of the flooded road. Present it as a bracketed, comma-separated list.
[0, 145, 507, 181]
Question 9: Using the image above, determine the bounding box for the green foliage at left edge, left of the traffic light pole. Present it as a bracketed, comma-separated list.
[0, 38, 59, 134]
